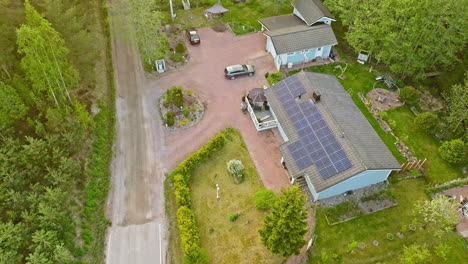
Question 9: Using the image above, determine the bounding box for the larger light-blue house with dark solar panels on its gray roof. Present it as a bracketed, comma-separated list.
[265, 72, 401, 200]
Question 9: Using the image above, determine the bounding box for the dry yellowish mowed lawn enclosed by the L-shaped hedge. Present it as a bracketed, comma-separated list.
[190, 133, 282, 264]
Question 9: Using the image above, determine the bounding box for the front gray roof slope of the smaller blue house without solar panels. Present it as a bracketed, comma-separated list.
[264, 24, 338, 54]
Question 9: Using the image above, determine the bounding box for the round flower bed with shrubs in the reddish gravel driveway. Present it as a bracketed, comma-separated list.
[159, 86, 205, 129]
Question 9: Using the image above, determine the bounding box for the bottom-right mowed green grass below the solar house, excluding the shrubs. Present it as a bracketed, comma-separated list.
[309, 178, 468, 264]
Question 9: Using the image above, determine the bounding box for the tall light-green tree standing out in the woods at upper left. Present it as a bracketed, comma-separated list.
[17, 0, 79, 106]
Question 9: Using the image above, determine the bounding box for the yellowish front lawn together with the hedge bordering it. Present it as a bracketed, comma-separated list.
[166, 128, 281, 263]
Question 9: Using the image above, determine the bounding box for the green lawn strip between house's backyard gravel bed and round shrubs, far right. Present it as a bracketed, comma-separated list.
[383, 106, 463, 183]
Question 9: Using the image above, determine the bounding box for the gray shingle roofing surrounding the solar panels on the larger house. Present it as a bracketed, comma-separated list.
[265, 72, 401, 192]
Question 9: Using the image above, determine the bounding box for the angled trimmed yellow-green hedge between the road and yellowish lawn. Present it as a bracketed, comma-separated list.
[169, 128, 233, 263]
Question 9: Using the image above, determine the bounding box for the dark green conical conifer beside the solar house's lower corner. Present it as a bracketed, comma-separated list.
[258, 186, 307, 258]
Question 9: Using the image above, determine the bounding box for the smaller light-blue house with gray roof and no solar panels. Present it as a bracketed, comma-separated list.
[259, 0, 338, 70]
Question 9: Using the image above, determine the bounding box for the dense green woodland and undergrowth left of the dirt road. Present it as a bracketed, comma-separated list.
[0, 0, 113, 263]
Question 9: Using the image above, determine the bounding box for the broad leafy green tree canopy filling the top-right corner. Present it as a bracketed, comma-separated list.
[325, 0, 468, 77]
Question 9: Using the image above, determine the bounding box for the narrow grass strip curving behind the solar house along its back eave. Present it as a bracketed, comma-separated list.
[291, 63, 406, 164]
